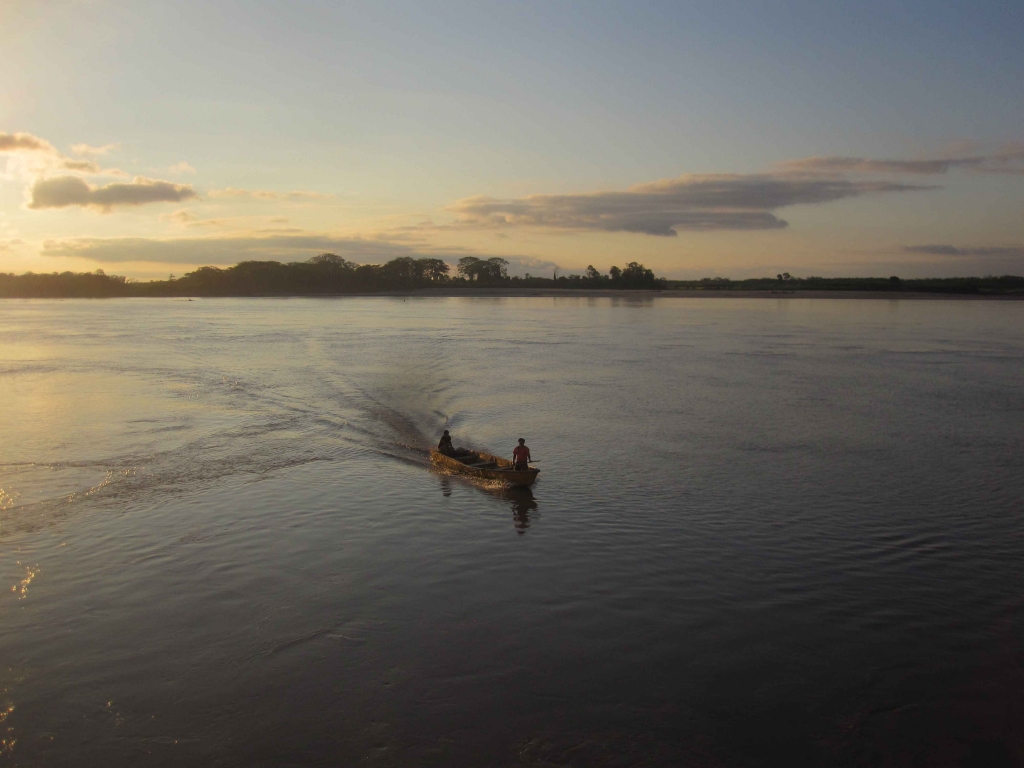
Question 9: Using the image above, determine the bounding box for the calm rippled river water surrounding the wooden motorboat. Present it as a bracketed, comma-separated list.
[0, 296, 1024, 768]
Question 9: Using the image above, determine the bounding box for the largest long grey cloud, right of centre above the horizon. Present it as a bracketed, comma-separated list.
[447, 174, 935, 237]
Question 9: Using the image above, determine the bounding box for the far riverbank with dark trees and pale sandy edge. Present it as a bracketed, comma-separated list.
[0, 264, 1024, 299]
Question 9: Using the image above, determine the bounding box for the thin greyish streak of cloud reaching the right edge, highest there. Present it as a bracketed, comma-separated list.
[776, 144, 1024, 175]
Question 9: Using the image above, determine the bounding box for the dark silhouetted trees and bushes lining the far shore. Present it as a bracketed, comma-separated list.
[0, 253, 1024, 298]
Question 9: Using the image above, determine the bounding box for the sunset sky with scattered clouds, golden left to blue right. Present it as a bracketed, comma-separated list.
[0, 0, 1024, 280]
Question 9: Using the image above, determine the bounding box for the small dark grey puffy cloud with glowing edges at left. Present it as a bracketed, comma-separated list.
[28, 176, 199, 213]
